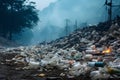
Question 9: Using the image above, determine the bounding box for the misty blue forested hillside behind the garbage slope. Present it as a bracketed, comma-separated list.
[14, 0, 120, 44]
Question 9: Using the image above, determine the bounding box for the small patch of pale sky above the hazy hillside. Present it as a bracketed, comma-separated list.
[30, 0, 57, 10]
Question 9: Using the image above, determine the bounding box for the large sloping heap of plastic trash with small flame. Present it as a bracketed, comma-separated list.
[1, 23, 120, 80]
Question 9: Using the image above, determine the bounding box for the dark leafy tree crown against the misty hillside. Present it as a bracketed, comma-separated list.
[0, 0, 39, 40]
